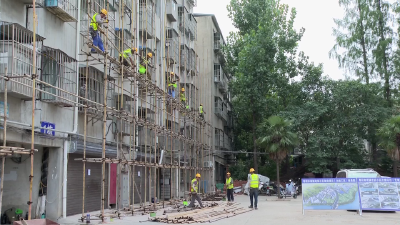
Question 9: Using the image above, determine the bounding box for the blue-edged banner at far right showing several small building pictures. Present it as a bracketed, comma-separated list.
[357, 178, 400, 211]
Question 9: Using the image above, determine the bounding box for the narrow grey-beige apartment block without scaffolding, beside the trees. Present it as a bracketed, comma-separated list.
[194, 13, 234, 183]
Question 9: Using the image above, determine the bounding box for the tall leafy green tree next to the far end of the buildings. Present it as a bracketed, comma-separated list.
[224, 0, 304, 170]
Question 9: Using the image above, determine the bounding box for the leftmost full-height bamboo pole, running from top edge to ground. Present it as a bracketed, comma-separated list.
[28, 0, 37, 220]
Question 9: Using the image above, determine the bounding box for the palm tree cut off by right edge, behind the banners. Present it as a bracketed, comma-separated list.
[378, 116, 400, 177]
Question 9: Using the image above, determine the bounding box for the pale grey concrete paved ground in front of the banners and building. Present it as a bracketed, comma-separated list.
[59, 195, 400, 225]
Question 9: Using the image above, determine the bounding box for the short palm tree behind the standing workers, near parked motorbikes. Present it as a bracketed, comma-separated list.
[258, 116, 297, 197]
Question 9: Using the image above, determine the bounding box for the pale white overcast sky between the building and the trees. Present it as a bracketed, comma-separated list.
[194, 0, 345, 80]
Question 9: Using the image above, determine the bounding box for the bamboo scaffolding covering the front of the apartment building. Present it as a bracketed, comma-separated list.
[0, 0, 214, 221]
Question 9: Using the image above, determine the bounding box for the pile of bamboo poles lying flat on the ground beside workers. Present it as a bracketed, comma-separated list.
[150, 202, 251, 224]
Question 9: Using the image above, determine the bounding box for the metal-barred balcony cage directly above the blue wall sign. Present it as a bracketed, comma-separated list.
[41, 46, 77, 107]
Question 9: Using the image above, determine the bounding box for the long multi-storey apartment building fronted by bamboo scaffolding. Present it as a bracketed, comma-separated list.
[0, 0, 216, 220]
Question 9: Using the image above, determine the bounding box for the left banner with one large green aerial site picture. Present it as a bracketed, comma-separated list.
[301, 178, 360, 210]
